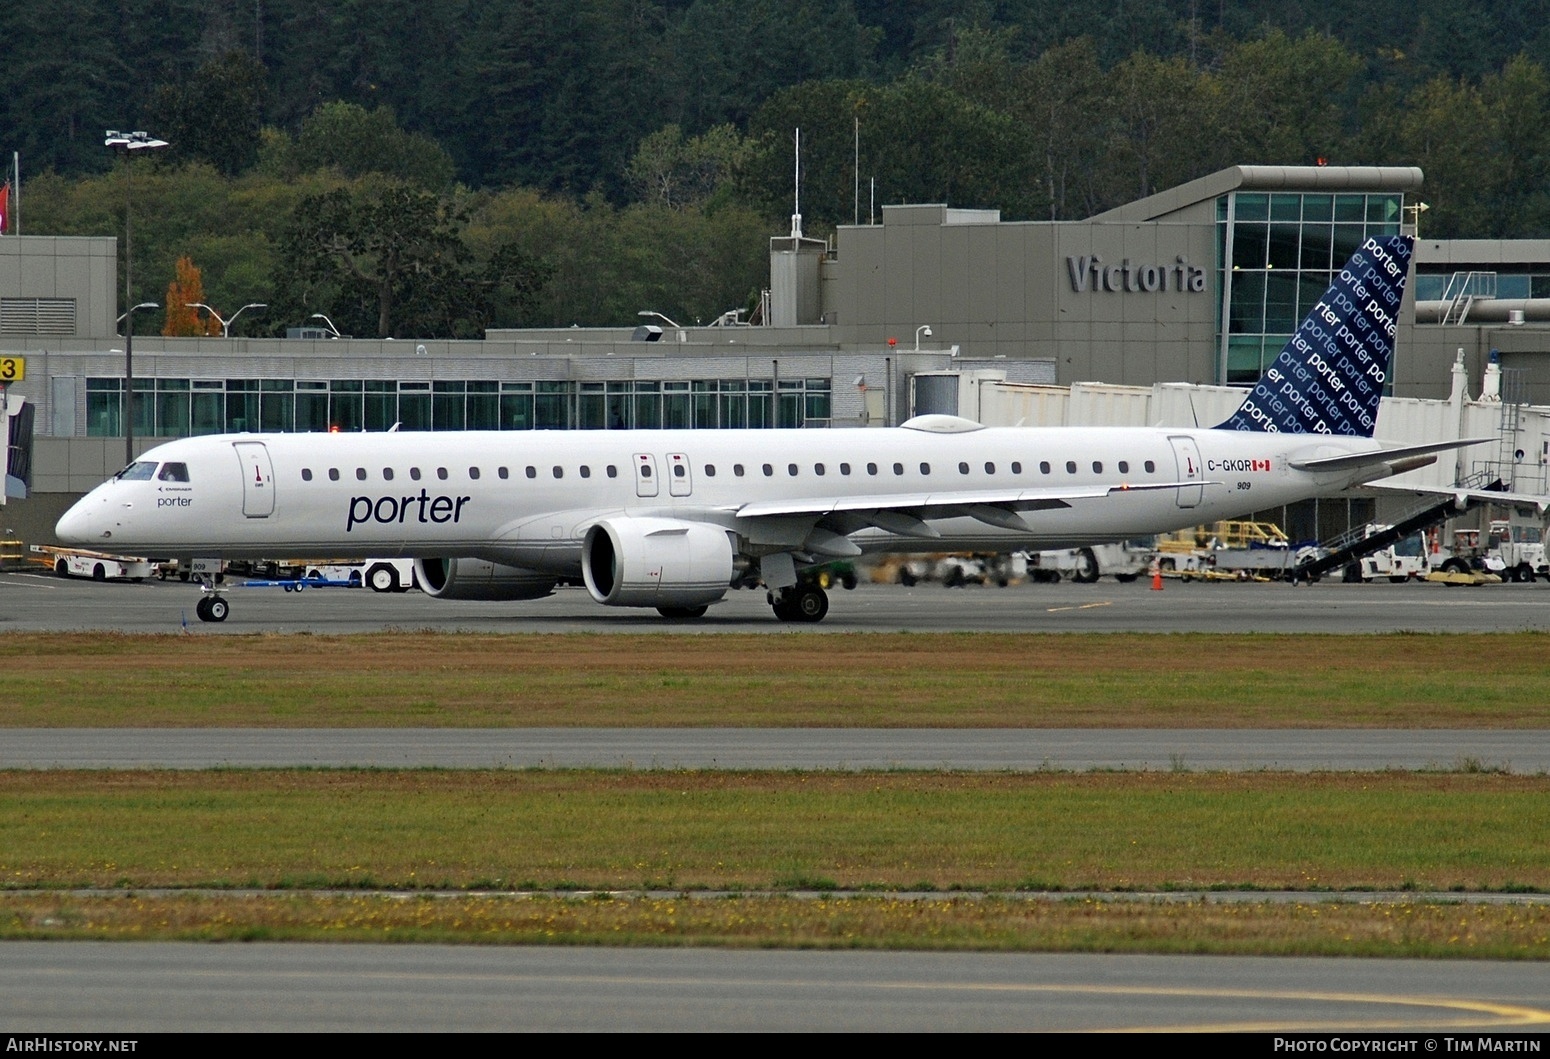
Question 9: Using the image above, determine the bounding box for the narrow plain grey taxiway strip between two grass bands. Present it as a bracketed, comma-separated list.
[0, 729, 1550, 774]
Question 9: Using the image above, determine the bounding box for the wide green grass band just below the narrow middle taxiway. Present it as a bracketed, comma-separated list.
[0, 771, 1550, 892]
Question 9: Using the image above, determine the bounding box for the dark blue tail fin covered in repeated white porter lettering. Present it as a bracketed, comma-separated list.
[1217, 236, 1411, 437]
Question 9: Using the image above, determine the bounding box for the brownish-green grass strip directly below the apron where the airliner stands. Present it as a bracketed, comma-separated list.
[0, 633, 1550, 729]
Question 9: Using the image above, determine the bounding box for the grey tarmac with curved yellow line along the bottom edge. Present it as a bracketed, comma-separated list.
[0, 943, 1550, 1035]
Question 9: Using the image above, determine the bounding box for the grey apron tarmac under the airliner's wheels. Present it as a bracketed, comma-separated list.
[0, 572, 1550, 634]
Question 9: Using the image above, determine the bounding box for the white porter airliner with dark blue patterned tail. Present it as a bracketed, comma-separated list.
[57, 237, 1473, 622]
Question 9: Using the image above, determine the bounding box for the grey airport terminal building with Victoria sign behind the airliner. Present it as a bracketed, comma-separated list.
[0, 166, 1550, 545]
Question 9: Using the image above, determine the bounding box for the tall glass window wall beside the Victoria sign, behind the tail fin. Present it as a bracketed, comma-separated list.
[1217, 191, 1403, 386]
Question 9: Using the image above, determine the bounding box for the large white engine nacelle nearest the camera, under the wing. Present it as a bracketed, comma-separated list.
[581, 518, 736, 608]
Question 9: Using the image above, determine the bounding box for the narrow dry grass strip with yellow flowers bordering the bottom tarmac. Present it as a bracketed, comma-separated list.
[0, 893, 1550, 960]
